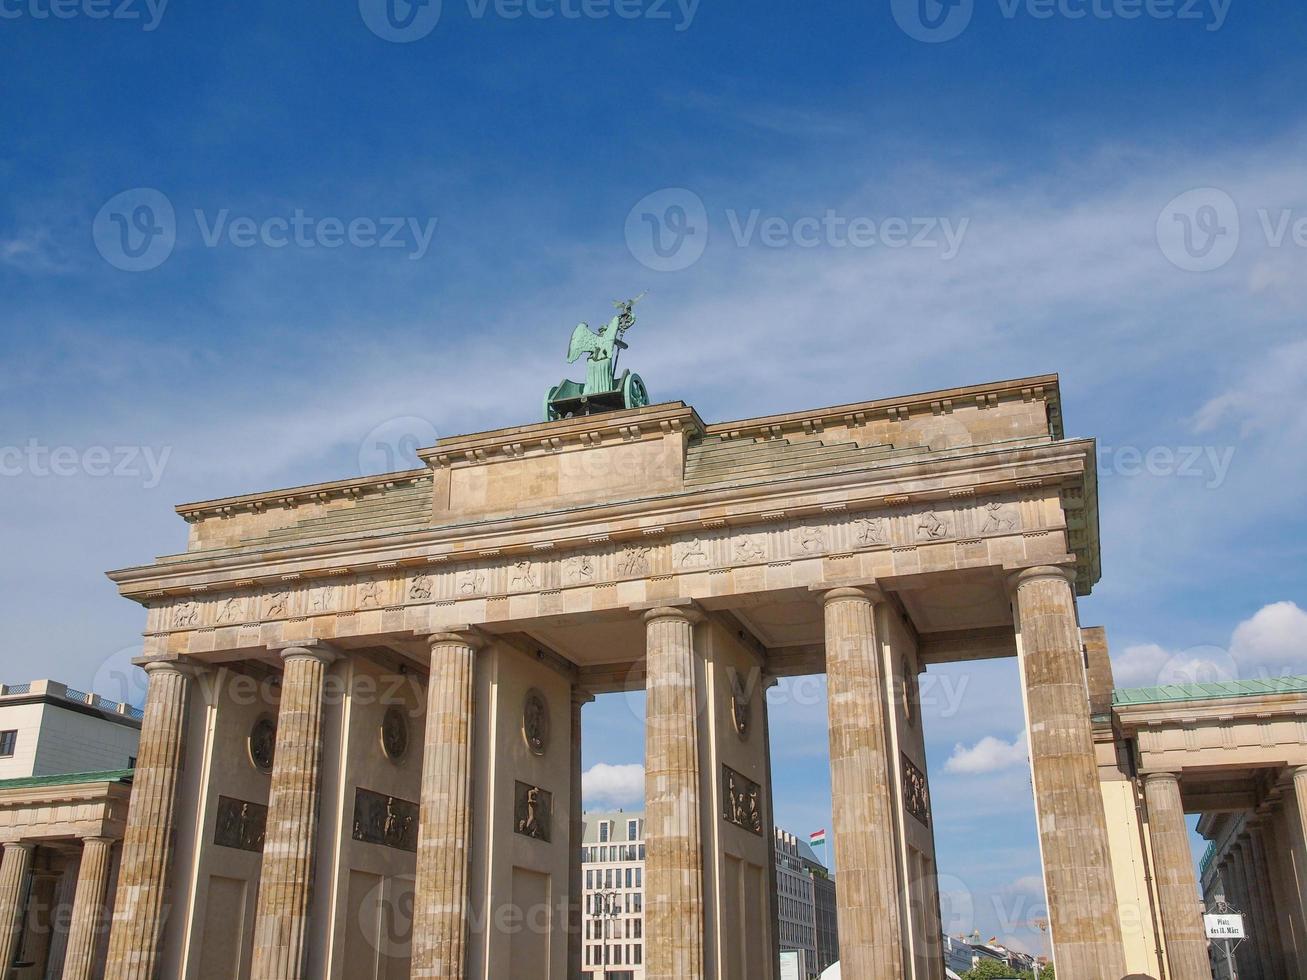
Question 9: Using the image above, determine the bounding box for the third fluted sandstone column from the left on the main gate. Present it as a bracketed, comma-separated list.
[413, 632, 480, 980]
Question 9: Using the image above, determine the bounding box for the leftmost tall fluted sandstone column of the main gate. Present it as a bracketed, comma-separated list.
[105, 660, 195, 980]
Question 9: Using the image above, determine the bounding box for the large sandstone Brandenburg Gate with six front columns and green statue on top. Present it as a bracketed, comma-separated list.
[96, 304, 1125, 980]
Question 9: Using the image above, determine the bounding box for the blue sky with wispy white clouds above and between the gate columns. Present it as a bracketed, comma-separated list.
[0, 0, 1307, 961]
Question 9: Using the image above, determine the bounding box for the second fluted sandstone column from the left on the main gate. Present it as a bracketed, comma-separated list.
[250, 647, 337, 980]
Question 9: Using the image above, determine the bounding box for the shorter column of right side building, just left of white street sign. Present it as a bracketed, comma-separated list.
[1144, 772, 1212, 980]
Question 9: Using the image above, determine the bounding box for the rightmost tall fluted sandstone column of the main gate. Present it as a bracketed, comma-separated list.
[1012, 566, 1125, 980]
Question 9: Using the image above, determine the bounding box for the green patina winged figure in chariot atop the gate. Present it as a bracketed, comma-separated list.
[545, 293, 650, 422]
